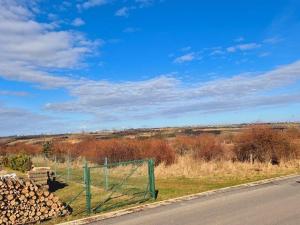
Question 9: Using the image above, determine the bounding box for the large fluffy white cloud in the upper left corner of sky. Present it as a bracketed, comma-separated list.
[0, 0, 101, 87]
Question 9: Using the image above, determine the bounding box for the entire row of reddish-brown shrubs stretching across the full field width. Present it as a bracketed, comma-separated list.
[0, 126, 300, 164]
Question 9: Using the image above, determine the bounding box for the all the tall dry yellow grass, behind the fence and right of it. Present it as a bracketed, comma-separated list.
[33, 156, 300, 179]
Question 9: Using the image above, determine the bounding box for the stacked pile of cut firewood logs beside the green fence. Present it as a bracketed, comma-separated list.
[0, 177, 69, 224]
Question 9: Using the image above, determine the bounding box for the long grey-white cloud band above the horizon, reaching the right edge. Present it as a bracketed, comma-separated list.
[46, 61, 300, 119]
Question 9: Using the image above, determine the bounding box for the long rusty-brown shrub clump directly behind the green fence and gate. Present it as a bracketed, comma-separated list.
[53, 138, 175, 165]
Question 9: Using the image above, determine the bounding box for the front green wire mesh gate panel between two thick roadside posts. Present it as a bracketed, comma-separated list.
[84, 159, 156, 213]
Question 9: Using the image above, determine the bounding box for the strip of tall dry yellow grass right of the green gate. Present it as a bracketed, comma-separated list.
[155, 156, 300, 178]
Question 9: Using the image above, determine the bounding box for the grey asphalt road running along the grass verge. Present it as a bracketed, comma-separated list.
[91, 176, 300, 225]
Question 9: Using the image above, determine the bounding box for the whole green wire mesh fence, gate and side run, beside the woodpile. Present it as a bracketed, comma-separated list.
[33, 155, 156, 215]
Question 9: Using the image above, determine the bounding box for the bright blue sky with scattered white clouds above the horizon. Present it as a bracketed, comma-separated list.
[0, 0, 300, 135]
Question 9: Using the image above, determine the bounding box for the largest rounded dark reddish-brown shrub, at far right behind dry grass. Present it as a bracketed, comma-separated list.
[234, 125, 299, 163]
